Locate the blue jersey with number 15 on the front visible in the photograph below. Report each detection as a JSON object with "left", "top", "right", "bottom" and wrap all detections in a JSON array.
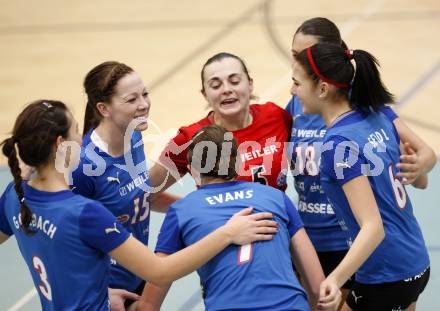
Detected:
[{"left": 72, "top": 131, "right": 150, "bottom": 291}]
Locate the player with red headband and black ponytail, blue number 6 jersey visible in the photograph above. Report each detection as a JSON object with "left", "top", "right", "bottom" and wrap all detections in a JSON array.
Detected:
[{"left": 292, "top": 43, "right": 429, "bottom": 310}]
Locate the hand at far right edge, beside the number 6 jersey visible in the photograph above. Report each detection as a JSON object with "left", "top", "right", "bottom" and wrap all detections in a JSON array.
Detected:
[{"left": 396, "top": 143, "right": 422, "bottom": 185}]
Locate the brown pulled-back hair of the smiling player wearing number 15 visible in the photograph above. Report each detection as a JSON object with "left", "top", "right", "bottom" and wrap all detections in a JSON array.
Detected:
[{"left": 83, "top": 61, "right": 133, "bottom": 135}]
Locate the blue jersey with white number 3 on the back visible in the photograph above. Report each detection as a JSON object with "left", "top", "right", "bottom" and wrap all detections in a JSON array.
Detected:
[{"left": 0, "top": 183, "right": 129, "bottom": 310}]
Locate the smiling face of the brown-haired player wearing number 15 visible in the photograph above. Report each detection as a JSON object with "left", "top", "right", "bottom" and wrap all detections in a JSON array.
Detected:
[{"left": 106, "top": 72, "right": 151, "bottom": 131}]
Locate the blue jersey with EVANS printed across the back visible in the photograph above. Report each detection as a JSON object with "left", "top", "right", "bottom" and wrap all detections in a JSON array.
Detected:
[{"left": 156, "top": 181, "right": 309, "bottom": 310}]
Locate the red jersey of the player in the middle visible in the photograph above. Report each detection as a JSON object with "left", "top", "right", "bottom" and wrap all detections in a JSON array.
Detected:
[{"left": 161, "top": 102, "right": 292, "bottom": 191}]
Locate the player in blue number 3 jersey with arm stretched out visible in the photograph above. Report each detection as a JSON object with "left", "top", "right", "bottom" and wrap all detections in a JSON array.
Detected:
[{"left": 0, "top": 100, "right": 276, "bottom": 310}]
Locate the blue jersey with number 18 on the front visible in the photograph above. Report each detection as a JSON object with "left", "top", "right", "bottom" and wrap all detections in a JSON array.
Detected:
[{"left": 286, "top": 96, "right": 349, "bottom": 252}]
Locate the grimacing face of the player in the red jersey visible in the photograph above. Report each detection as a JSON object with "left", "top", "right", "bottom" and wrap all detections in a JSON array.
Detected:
[{"left": 202, "top": 57, "right": 253, "bottom": 117}]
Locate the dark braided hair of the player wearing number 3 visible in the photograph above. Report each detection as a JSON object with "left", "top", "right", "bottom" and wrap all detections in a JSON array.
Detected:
[{"left": 0, "top": 100, "right": 72, "bottom": 235}]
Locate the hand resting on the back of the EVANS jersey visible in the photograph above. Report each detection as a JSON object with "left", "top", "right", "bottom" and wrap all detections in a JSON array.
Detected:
[{"left": 224, "top": 207, "right": 278, "bottom": 245}]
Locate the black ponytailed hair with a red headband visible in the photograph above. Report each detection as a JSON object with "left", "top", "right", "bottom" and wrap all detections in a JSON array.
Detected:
[{"left": 295, "top": 43, "right": 394, "bottom": 113}]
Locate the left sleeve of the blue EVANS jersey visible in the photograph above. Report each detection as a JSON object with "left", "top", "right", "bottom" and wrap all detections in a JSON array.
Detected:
[{"left": 154, "top": 206, "right": 185, "bottom": 254}]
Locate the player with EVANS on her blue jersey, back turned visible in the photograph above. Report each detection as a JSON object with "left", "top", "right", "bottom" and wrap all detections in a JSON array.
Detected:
[{"left": 142, "top": 125, "right": 340, "bottom": 310}]
